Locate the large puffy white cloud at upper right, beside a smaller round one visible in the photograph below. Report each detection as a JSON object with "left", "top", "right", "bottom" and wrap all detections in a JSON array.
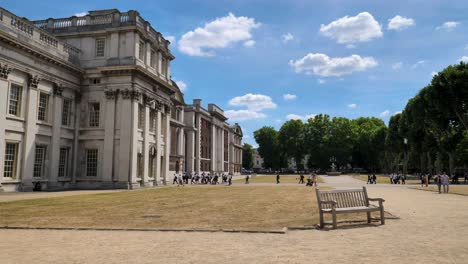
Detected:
[{"left": 320, "top": 12, "right": 383, "bottom": 44}]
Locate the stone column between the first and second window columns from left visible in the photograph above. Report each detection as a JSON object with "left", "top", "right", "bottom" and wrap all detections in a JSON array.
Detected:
[{"left": 21, "top": 75, "right": 40, "bottom": 191}]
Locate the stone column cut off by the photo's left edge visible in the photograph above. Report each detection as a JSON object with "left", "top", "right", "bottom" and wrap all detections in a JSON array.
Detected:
[{"left": 0, "top": 64, "right": 12, "bottom": 192}]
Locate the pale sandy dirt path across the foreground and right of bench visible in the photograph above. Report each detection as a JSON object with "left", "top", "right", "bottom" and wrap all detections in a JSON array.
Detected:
[{"left": 0, "top": 176, "right": 468, "bottom": 264}]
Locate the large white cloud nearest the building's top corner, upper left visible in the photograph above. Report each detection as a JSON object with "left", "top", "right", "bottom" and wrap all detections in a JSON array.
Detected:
[{"left": 179, "top": 13, "right": 260, "bottom": 56}]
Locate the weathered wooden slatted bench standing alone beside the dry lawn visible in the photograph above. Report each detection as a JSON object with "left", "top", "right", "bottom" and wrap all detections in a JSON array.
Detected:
[{"left": 315, "top": 187, "right": 385, "bottom": 228}]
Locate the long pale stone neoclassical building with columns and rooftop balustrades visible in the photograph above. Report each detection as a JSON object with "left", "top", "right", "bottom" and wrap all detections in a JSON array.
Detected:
[{"left": 0, "top": 8, "right": 242, "bottom": 191}]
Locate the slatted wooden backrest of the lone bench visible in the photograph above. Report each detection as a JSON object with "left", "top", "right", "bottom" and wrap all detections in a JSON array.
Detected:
[{"left": 316, "top": 187, "right": 369, "bottom": 209}]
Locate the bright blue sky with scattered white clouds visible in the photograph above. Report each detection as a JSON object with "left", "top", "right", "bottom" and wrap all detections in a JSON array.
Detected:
[{"left": 0, "top": 0, "right": 468, "bottom": 146}]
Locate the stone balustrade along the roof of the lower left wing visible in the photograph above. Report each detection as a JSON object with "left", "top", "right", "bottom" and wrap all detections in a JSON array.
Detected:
[{"left": 0, "top": 8, "right": 80, "bottom": 65}]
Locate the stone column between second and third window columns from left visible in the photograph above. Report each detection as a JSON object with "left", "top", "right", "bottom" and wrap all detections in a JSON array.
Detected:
[{"left": 47, "top": 85, "right": 63, "bottom": 189}]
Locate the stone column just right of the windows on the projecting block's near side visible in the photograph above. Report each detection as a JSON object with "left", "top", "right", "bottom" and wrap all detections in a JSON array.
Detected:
[{"left": 102, "top": 90, "right": 118, "bottom": 187}]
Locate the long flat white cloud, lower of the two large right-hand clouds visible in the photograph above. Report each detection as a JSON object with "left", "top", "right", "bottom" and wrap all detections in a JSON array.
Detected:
[{"left": 289, "top": 53, "right": 378, "bottom": 77}]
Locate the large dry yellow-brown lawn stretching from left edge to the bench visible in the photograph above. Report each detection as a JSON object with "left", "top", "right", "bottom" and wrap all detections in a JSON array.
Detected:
[{"left": 0, "top": 186, "right": 340, "bottom": 230}]
